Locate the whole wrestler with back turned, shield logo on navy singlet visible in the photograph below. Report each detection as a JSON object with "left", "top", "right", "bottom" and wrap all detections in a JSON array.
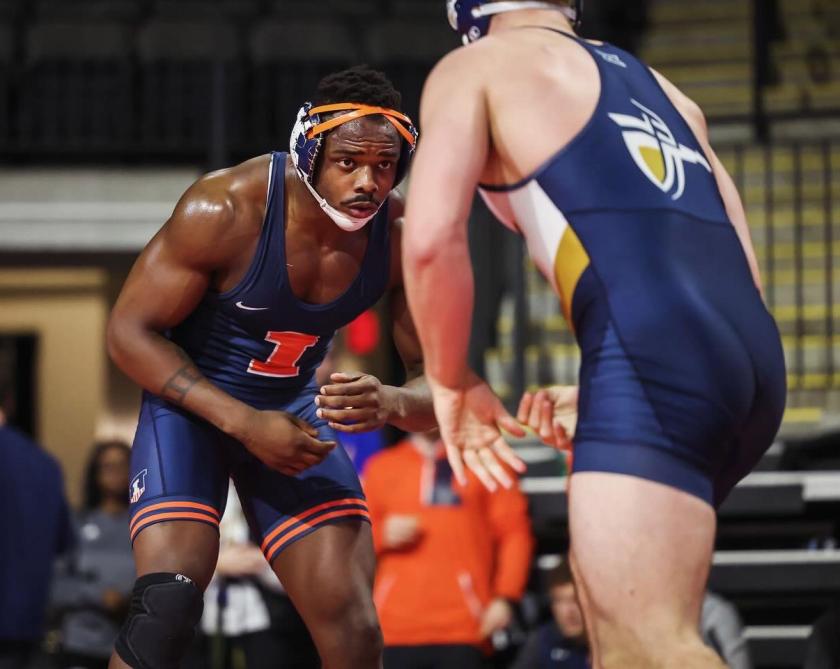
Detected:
[{"left": 403, "top": 0, "right": 785, "bottom": 669}]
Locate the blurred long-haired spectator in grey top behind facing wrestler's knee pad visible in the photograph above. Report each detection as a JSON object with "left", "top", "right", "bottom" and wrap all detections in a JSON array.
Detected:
[{"left": 52, "top": 441, "right": 134, "bottom": 669}]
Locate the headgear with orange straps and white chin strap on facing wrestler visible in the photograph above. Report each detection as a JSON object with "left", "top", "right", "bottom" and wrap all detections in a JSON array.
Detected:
[{"left": 289, "top": 102, "right": 418, "bottom": 232}]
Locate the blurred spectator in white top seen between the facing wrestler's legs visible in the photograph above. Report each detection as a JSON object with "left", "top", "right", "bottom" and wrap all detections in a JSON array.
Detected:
[{"left": 184, "top": 485, "right": 320, "bottom": 669}]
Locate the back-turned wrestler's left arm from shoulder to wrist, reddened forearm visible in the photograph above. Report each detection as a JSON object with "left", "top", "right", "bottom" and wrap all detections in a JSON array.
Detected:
[{"left": 403, "top": 51, "right": 489, "bottom": 388}]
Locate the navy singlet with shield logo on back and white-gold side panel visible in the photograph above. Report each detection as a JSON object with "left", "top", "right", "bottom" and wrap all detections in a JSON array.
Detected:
[{"left": 482, "top": 27, "right": 786, "bottom": 504}]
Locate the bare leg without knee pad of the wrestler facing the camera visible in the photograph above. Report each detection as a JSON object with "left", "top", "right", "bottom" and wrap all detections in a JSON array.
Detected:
[{"left": 272, "top": 520, "right": 382, "bottom": 669}]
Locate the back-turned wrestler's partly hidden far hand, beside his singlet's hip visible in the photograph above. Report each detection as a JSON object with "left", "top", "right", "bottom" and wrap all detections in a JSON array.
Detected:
[{"left": 516, "top": 386, "right": 578, "bottom": 451}]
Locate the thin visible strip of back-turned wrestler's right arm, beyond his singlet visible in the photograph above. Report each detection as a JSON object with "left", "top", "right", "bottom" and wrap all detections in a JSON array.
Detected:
[{"left": 653, "top": 70, "right": 761, "bottom": 291}]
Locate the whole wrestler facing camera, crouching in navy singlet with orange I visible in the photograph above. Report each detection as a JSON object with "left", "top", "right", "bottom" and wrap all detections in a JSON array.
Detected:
[{"left": 108, "top": 68, "right": 433, "bottom": 669}]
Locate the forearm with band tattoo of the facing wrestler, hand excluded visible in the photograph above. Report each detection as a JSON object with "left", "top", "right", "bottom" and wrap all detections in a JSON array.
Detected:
[{"left": 108, "top": 326, "right": 253, "bottom": 437}]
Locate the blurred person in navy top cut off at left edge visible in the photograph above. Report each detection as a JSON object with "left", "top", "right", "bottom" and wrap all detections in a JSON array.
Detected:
[{"left": 0, "top": 366, "right": 73, "bottom": 669}]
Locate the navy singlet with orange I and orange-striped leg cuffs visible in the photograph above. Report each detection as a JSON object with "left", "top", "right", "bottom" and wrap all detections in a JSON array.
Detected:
[{"left": 131, "top": 152, "right": 390, "bottom": 560}]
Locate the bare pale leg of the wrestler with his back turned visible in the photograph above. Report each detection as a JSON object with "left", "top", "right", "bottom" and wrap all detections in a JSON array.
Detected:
[{"left": 569, "top": 471, "right": 724, "bottom": 669}]
